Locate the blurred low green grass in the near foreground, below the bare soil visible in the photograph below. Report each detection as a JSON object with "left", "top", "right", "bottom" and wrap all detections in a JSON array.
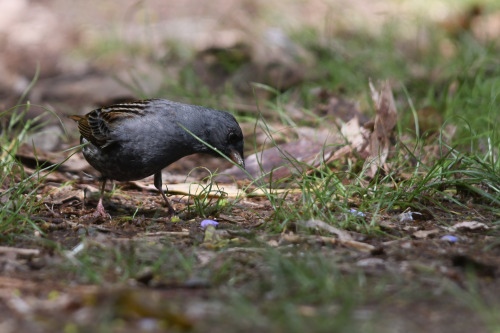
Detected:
[{"left": 52, "top": 239, "right": 498, "bottom": 332}]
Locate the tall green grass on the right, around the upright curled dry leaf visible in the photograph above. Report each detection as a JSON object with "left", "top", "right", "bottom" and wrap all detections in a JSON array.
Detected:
[{"left": 252, "top": 16, "right": 500, "bottom": 231}]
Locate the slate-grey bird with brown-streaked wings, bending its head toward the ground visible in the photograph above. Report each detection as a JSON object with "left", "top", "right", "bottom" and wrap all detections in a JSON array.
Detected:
[{"left": 70, "top": 99, "right": 245, "bottom": 218}]
